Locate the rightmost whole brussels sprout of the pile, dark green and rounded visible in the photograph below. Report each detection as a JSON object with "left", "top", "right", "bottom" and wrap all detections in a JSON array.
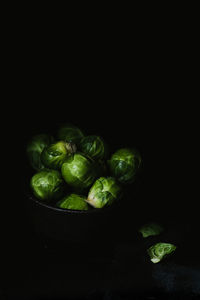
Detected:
[{"left": 108, "top": 148, "right": 141, "bottom": 184}]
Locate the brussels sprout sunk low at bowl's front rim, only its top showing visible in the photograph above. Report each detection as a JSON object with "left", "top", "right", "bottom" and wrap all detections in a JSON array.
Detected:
[{"left": 56, "top": 194, "right": 89, "bottom": 210}]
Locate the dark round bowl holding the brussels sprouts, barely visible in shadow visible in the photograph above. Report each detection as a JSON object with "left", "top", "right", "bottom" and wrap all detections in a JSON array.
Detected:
[{"left": 26, "top": 188, "right": 122, "bottom": 242}]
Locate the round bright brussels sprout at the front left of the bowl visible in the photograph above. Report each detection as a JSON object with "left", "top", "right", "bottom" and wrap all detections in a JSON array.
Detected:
[{"left": 30, "top": 170, "right": 64, "bottom": 202}]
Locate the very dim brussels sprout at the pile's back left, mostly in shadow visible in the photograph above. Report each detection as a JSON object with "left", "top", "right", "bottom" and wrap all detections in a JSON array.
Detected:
[{"left": 26, "top": 134, "right": 53, "bottom": 171}]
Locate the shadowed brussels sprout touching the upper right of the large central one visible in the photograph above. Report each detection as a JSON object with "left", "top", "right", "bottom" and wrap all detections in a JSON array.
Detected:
[{"left": 79, "top": 135, "right": 108, "bottom": 160}]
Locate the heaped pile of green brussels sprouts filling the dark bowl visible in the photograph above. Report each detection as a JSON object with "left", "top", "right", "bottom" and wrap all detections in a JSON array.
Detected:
[{"left": 26, "top": 124, "right": 141, "bottom": 210}]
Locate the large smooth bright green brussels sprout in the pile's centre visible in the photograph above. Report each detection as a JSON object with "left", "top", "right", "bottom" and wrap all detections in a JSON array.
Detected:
[{"left": 61, "top": 152, "right": 97, "bottom": 190}]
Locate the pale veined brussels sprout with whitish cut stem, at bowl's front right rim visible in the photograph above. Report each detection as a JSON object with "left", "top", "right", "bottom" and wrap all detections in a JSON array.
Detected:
[{"left": 86, "top": 177, "right": 121, "bottom": 208}]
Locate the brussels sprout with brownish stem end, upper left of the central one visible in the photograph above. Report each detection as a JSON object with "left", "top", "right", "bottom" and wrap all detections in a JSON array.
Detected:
[{"left": 41, "top": 141, "right": 76, "bottom": 170}]
